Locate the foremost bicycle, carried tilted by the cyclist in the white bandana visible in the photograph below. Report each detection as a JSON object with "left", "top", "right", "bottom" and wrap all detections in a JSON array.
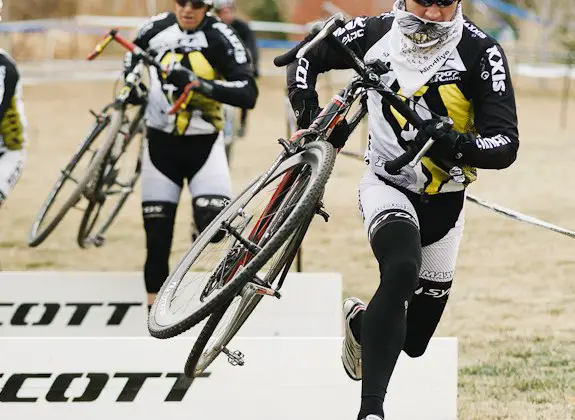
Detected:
[{"left": 148, "top": 14, "right": 448, "bottom": 377}]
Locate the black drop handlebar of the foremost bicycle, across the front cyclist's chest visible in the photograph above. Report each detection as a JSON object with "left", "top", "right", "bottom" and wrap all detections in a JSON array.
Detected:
[{"left": 274, "top": 13, "right": 435, "bottom": 175}]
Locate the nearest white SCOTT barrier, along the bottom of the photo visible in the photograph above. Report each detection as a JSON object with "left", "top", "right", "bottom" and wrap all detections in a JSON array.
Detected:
[{"left": 0, "top": 338, "right": 457, "bottom": 420}]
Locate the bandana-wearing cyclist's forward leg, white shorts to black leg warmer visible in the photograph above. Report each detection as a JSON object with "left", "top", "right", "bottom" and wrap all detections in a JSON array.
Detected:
[{"left": 351, "top": 171, "right": 421, "bottom": 419}]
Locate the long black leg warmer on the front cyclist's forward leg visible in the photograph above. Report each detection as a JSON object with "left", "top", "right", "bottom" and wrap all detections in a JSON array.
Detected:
[{"left": 359, "top": 212, "right": 421, "bottom": 418}]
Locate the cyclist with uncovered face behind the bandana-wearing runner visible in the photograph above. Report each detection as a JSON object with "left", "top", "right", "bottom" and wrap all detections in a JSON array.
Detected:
[{"left": 125, "top": 0, "right": 258, "bottom": 304}]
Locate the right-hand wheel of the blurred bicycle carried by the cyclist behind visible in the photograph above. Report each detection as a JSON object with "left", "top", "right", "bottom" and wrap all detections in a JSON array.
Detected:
[{"left": 77, "top": 109, "right": 146, "bottom": 248}]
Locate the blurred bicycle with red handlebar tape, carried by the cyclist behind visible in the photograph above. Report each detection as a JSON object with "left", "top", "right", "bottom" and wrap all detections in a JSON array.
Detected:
[{"left": 28, "top": 34, "right": 147, "bottom": 248}]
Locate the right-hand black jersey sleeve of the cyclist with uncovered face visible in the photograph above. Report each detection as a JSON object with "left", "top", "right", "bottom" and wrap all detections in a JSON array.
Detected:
[{"left": 201, "top": 22, "right": 258, "bottom": 109}]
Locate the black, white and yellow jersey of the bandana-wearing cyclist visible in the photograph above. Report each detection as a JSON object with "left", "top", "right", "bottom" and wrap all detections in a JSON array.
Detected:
[{"left": 288, "top": 13, "right": 519, "bottom": 195}]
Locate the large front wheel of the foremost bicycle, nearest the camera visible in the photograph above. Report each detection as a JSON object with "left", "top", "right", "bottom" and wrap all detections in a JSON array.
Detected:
[{"left": 148, "top": 141, "right": 335, "bottom": 338}]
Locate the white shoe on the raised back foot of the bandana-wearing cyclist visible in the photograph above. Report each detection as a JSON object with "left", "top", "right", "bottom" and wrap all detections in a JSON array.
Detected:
[{"left": 341, "top": 297, "right": 364, "bottom": 380}]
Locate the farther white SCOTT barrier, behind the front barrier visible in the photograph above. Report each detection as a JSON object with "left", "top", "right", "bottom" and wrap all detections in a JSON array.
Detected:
[{"left": 0, "top": 271, "right": 342, "bottom": 337}]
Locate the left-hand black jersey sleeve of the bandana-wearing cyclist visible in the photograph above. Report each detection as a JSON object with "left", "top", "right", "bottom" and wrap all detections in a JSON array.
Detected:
[{"left": 287, "top": 16, "right": 383, "bottom": 107}]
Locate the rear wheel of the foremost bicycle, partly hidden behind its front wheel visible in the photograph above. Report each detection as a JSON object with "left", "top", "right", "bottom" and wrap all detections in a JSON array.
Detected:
[{"left": 184, "top": 213, "right": 313, "bottom": 378}]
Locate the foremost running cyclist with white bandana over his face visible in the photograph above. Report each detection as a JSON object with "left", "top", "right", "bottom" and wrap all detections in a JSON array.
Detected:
[{"left": 287, "top": 0, "right": 519, "bottom": 420}]
